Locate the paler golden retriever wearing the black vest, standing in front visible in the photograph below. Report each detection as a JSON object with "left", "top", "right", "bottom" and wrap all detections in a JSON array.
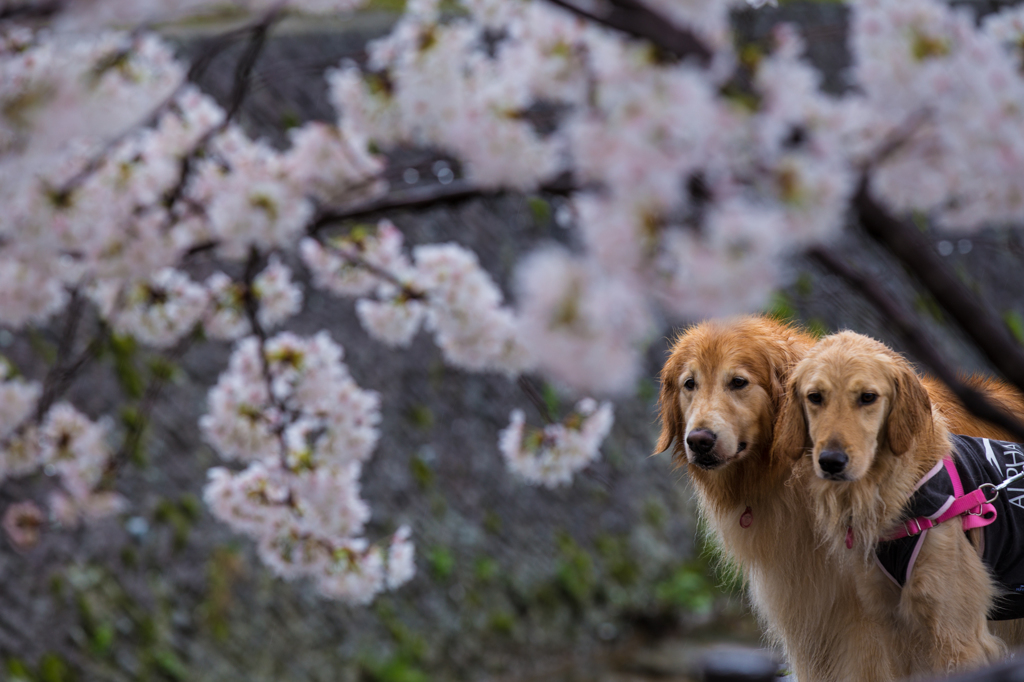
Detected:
[{"left": 775, "top": 332, "right": 1007, "bottom": 675}]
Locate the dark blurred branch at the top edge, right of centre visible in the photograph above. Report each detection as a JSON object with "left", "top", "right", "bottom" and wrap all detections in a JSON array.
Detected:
[{"left": 548, "top": 0, "right": 712, "bottom": 67}]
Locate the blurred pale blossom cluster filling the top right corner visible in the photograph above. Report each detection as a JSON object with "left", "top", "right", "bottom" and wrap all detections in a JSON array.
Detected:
[{"left": 853, "top": 0, "right": 1024, "bottom": 228}]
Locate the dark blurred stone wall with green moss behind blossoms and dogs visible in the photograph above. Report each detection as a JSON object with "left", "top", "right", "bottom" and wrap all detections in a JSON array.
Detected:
[{"left": 6, "top": 2, "right": 1024, "bottom": 682}]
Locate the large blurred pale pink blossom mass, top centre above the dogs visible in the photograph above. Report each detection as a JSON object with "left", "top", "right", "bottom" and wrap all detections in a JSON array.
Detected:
[{"left": 332, "top": 0, "right": 866, "bottom": 392}]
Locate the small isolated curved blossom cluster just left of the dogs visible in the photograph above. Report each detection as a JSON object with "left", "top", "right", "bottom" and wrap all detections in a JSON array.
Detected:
[{"left": 498, "top": 398, "right": 612, "bottom": 487}]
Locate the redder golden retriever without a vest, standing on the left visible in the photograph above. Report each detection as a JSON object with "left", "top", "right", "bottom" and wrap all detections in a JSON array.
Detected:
[{"left": 655, "top": 316, "right": 1024, "bottom": 682}]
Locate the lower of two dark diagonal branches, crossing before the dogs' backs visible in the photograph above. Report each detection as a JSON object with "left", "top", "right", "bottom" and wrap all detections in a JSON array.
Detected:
[{"left": 807, "top": 242, "right": 1024, "bottom": 442}]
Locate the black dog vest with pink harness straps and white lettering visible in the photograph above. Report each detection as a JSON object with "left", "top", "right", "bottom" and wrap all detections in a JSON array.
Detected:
[{"left": 872, "top": 435, "right": 1024, "bottom": 621}]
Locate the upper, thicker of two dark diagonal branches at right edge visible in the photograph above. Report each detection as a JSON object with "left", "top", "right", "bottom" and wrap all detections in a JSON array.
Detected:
[{"left": 854, "top": 176, "right": 1024, "bottom": 395}]
